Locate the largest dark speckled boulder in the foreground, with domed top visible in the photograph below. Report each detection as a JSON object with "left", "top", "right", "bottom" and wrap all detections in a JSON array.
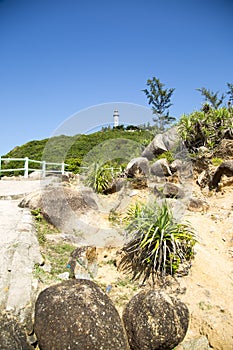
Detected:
[{"left": 34, "top": 279, "right": 129, "bottom": 350}]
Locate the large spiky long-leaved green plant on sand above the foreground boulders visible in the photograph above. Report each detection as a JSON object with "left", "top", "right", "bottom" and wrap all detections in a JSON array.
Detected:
[{"left": 120, "top": 201, "right": 196, "bottom": 283}]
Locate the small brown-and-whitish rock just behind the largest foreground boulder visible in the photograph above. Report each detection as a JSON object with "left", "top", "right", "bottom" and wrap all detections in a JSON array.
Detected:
[{"left": 68, "top": 246, "right": 98, "bottom": 279}]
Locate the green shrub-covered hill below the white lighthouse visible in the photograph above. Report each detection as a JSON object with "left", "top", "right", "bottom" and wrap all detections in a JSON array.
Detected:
[{"left": 2, "top": 129, "right": 153, "bottom": 172}]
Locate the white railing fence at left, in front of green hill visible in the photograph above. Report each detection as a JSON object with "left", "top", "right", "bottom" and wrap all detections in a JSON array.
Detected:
[{"left": 0, "top": 156, "right": 68, "bottom": 179}]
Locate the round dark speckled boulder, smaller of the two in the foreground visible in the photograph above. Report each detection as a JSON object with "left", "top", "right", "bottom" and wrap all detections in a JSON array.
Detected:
[{"left": 123, "top": 290, "right": 189, "bottom": 350}]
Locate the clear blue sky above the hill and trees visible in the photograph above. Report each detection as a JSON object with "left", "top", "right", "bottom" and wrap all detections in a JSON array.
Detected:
[{"left": 0, "top": 0, "right": 233, "bottom": 155}]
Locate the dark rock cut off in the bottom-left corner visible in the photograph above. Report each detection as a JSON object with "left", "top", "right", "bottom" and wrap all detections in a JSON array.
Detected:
[{"left": 0, "top": 313, "right": 34, "bottom": 350}]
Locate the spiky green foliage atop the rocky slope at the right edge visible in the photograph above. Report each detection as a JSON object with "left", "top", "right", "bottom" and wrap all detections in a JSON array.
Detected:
[{"left": 178, "top": 107, "right": 233, "bottom": 151}]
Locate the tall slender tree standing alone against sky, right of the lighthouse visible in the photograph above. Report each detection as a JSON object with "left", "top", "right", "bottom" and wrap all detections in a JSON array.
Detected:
[{"left": 142, "top": 77, "right": 175, "bottom": 130}]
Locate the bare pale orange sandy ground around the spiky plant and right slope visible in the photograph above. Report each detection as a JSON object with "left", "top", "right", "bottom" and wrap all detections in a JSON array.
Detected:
[{"left": 94, "top": 185, "right": 233, "bottom": 350}]
